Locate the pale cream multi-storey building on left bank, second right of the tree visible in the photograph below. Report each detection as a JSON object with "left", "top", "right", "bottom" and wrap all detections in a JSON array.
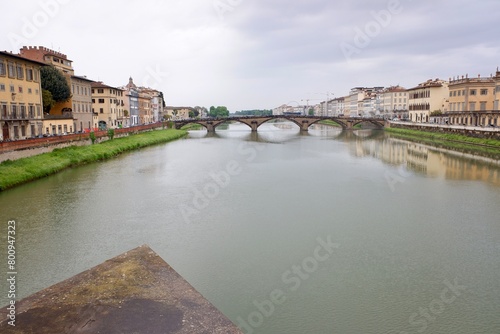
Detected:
[{"left": 91, "top": 81, "right": 125, "bottom": 129}]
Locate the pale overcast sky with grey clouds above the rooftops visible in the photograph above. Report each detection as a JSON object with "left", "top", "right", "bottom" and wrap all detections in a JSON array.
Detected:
[{"left": 0, "top": 0, "right": 500, "bottom": 112}]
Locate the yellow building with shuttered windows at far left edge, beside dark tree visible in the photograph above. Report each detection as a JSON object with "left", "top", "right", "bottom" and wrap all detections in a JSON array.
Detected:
[{"left": 0, "top": 51, "right": 44, "bottom": 140}]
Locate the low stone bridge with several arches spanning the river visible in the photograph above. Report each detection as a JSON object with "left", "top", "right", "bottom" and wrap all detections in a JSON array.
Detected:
[{"left": 173, "top": 115, "right": 385, "bottom": 132}]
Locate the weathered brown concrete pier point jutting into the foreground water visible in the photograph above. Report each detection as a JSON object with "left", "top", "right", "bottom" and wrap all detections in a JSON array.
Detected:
[{"left": 0, "top": 246, "right": 242, "bottom": 334}]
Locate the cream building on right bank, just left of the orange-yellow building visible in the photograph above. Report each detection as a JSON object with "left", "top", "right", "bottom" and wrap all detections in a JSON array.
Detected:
[{"left": 408, "top": 79, "right": 449, "bottom": 123}]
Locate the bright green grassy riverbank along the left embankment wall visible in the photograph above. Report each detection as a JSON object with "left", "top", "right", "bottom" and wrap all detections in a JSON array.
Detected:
[{"left": 0, "top": 129, "right": 187, "bottom": 191}]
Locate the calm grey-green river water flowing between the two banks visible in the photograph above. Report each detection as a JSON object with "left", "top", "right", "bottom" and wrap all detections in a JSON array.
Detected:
[{"left": 0, "top": 123, "right": 500, "bottom": 334}]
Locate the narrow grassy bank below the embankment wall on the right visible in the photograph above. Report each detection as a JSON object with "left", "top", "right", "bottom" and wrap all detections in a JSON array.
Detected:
[{"left": 384, "top": 128, "right": 500, "bottom": 159}]
